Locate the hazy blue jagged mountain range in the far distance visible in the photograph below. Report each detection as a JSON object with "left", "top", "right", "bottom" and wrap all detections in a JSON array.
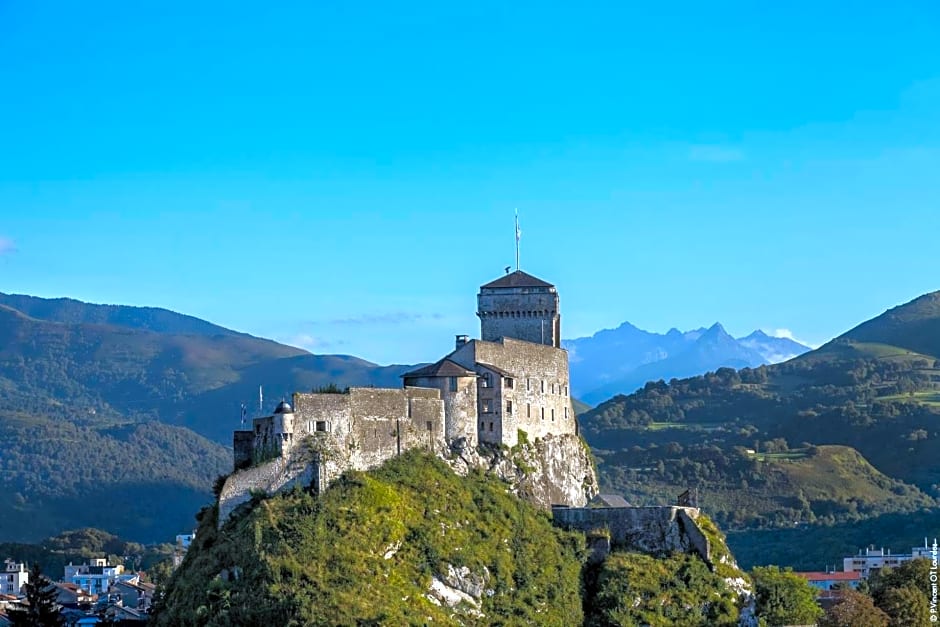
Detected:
[{"left": 562, "top": 322, "right": 810, "bottom": 404}]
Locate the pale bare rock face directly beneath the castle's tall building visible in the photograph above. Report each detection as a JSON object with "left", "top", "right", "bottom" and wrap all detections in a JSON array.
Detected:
[{"left": 444, "top": 432, "right": 597, "bottom": 509}]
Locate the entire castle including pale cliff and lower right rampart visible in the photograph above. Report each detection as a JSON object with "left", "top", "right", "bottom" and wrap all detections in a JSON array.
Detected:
[{"left": 218, "top": 270, "right": 713, "bottom": 588}]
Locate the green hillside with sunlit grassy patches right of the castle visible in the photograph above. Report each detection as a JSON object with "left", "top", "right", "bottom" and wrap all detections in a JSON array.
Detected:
[{"left": 580, "top": 293, "right": 940, "bottom": 568}]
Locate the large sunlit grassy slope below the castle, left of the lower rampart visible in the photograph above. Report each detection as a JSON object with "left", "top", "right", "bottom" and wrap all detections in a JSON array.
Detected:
[{"left": 154, "top": 452, "right": 583, "bottom": 626}]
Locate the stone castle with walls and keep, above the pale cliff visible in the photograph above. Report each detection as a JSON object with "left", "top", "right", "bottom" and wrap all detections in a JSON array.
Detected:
[{"left": 220, "top": 270, "right": 593, "bottom": 511}]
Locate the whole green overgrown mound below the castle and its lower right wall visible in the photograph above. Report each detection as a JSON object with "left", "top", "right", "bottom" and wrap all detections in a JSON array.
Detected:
[{"left": 153, "top": 451, "right": 740, "bottom": 627}]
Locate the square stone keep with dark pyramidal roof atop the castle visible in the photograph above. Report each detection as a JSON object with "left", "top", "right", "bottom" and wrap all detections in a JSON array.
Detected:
[{"left": 477, "top": 270, "right": 561, "bottom": 348}]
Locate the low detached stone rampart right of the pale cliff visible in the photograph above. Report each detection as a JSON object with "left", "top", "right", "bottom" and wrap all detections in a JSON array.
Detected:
[{"left": 552, "top": 506, "right": 712, "bottom": 566}]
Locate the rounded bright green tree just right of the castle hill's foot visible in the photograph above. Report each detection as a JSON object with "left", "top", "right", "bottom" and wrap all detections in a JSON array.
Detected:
[{"left": 751, "top": 566, "right": 823, "bottom": 625}]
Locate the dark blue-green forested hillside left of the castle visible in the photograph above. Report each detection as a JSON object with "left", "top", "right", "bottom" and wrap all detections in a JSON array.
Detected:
[{"left": 0, "top": 294, "right": 408, "bottom": 542}]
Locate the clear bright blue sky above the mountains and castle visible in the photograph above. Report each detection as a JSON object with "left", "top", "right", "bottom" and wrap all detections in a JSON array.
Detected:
[{"left": 0, "top": 1, "right": 940, "bottom": 363}]
